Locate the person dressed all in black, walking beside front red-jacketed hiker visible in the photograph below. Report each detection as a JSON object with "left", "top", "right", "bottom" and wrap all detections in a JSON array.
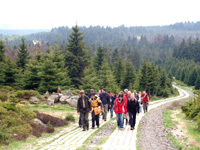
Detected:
[{"left": 127, "top": 94, "right": 139, "bottom": 130}]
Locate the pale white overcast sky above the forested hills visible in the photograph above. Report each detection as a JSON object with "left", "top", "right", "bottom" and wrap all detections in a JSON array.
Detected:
[{"left": 0, "top": 0, "right": 200, "bottom": 29}]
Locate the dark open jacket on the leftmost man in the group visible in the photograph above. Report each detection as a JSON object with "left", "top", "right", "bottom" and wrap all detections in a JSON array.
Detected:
[{"left": 77, "top": 96, "right": 91, "bottom": 113}]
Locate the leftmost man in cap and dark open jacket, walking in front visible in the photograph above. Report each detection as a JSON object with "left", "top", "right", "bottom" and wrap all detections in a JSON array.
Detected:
[{"left": 77, "top": 90, "right": 91, "bottom": 131}]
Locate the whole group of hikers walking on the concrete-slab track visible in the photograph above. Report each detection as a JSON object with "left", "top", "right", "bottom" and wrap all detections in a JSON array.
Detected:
[{"left": 77, "top": 88, "right": 149, "bottom": 131}]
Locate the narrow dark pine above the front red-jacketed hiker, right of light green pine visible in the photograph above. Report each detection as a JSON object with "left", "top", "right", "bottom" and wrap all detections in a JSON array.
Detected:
[{"left": 114, "top": 56, "right": 124, "bottom": 86}]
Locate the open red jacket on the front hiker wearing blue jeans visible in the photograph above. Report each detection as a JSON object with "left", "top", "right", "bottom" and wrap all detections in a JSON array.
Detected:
[{"left": 114, "top": 98, "right": 127, "bottom": 114}]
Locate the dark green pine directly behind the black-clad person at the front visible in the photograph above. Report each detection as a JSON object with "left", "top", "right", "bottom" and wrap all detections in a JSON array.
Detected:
[{"left": 121, "top": 61, "right": 136, "bottom": 89}]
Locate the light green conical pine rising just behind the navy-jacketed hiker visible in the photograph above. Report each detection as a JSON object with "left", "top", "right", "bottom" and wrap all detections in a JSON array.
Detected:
[{"left": 99, "top": 62, "right": 119, "bottom": 93}]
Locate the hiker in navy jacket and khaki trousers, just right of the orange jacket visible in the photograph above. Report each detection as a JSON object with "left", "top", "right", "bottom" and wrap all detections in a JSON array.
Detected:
[{"left": 99, "top": 88, "right": 110, "bottom": 121}]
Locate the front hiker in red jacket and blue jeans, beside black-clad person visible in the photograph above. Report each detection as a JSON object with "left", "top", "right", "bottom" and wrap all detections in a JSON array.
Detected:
[{"left": 114, "top": 91, "right": 127, "bottom": 130}]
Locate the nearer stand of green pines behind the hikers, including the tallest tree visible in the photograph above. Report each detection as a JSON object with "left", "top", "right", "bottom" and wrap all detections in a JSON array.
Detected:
[{"left": 0, "top": 26, "right": 174, "bottom": 97}]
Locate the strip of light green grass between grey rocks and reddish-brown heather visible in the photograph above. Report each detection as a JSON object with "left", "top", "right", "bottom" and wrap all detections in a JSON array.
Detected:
[{"left": 24, "top": 104, "right": 76, "bottom": 112}]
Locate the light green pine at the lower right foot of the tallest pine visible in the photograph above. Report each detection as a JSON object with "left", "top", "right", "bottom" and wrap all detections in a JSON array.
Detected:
[{"left": 81, "top": 65, "right": 99, "bottom": 93}]
